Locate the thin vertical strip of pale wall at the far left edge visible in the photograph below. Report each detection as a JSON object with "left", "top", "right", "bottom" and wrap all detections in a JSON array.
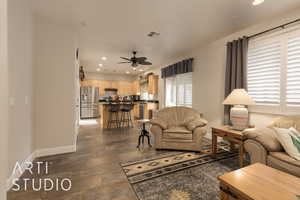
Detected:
[{"left": 0, "top": 0, "right": 8, "bottom": 197}]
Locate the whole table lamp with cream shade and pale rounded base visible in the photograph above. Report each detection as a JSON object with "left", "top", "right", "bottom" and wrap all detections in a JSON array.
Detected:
[{"left": 223, "top": 89, "right": 255, "bottom": 131}]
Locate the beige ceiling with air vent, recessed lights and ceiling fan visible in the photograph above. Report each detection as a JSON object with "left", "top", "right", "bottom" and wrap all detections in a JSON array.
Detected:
[{"left": 32, "top": 0, "right": 300, "bottom": 74}]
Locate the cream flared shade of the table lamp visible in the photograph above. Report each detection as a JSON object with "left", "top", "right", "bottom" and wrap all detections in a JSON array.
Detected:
[{"left": 223, "top": 89, "right": 255, "bottom": 105}]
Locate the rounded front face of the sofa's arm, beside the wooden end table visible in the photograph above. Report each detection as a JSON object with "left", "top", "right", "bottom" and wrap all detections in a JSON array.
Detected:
[{"left": 244, "top": 139, "right": 268, "bottom": 164}]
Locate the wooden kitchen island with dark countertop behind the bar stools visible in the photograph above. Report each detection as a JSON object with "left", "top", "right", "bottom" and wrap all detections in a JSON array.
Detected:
[{"left": 99, "top": 100, "right": 159, "bottom": 128}]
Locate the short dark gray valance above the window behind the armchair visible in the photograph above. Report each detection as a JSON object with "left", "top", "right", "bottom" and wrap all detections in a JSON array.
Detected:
[{"left": 161, "top": 58, "right": 193, "bottom": 78}]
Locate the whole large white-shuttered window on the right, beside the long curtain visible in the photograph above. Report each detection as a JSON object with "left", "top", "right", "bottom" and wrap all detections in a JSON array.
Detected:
[{"left": 247, "top": 27, "right": 300, "bottom": 114}]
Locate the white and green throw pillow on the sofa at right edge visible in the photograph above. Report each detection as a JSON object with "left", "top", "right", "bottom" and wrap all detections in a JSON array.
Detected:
[{"left": 274, "top": 128, "right": 300, "bottom": 160}]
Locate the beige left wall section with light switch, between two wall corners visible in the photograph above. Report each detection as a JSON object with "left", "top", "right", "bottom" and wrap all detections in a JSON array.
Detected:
[{"left": 8, "top": 0, "right": 34, "bottom": 180}]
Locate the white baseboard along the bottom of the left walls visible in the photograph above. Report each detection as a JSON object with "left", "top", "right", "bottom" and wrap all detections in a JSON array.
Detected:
[{"left": 6, "top": 144, "right": 76, "bottom": 191}]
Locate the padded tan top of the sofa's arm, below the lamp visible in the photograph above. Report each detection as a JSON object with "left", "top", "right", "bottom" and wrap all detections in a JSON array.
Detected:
[{"left": 243, "top": 128, "right": 283, "bottom": 152}]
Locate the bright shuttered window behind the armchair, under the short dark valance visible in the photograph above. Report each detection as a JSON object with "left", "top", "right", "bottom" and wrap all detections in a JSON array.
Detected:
[{"left": 165, "top": 73, "right": 193, "bottom": 107}]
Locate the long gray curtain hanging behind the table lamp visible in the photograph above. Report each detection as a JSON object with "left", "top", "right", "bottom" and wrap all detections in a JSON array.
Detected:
[{"left": 224, "top": 37, "right": 248, "bottom": 125}]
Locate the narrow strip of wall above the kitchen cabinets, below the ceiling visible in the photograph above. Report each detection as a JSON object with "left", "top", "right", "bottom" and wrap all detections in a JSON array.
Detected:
[{"left": 85, "top": 72, "right": 137, "bottom": 81}]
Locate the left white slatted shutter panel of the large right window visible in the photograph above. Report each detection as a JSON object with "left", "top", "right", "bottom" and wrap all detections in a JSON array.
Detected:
[{"left": 247, "top": 40, "right": 281, "bottom": 106}]
